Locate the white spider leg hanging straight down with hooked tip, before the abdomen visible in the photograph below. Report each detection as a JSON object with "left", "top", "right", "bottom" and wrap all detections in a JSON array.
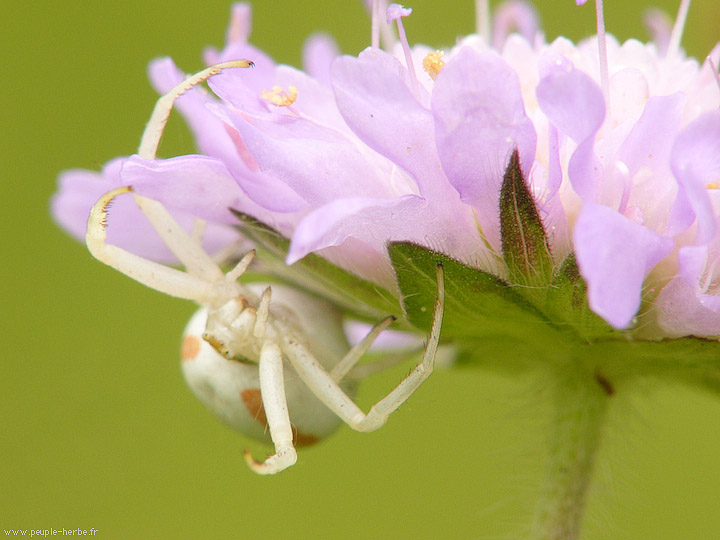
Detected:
[{"left": 244, "top": 340, "right": 297, "bottom": 474}]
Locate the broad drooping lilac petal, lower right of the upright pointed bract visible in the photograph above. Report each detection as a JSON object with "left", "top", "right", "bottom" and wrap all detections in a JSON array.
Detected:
[{"left": 573, "top": 203, "right": 673, "bottom": 328}]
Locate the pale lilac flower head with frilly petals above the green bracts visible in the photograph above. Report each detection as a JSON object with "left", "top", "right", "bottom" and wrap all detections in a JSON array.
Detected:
[{"left": 53, "top": 1, "right": 720, "bottom": 339}]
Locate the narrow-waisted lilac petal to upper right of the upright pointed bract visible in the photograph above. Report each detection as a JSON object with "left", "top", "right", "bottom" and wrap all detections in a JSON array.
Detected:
[{"left": 536, "top": 68, "right": 605, "bottom": 200}]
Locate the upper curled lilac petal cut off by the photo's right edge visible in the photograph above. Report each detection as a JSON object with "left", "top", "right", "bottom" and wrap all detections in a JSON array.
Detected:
[{"left": 670, "top": 111, "right": 720, "bottom": 244}]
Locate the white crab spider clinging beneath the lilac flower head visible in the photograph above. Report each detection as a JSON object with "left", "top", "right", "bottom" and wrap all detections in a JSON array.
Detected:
[{"left": 86, "top": 60, "right": 444, "bottom": 474}]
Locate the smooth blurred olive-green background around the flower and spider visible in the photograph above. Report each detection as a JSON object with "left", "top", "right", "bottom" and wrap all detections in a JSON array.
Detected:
[{"left": 0, "top": 0, "right": 720, "bottom": 540}]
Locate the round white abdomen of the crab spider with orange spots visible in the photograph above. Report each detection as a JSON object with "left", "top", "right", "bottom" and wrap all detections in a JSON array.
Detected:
[{"left": 181, "top": 284, "right": 380, "bottom": 447}]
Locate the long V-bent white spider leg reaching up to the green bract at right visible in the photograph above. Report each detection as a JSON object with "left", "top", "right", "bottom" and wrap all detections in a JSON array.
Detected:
[{"left": 282, "top": 265, "right": 445, "bottom": 431}]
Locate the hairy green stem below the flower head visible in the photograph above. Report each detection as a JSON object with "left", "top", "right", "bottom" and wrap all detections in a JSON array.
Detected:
[{"left": 530, "top": 365, "right": 613, "bottom": 540}]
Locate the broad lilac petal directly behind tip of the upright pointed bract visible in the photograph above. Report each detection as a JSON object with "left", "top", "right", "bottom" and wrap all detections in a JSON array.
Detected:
[{"left": 432, "top": 47, "right": 536, "bottom": 249}]
